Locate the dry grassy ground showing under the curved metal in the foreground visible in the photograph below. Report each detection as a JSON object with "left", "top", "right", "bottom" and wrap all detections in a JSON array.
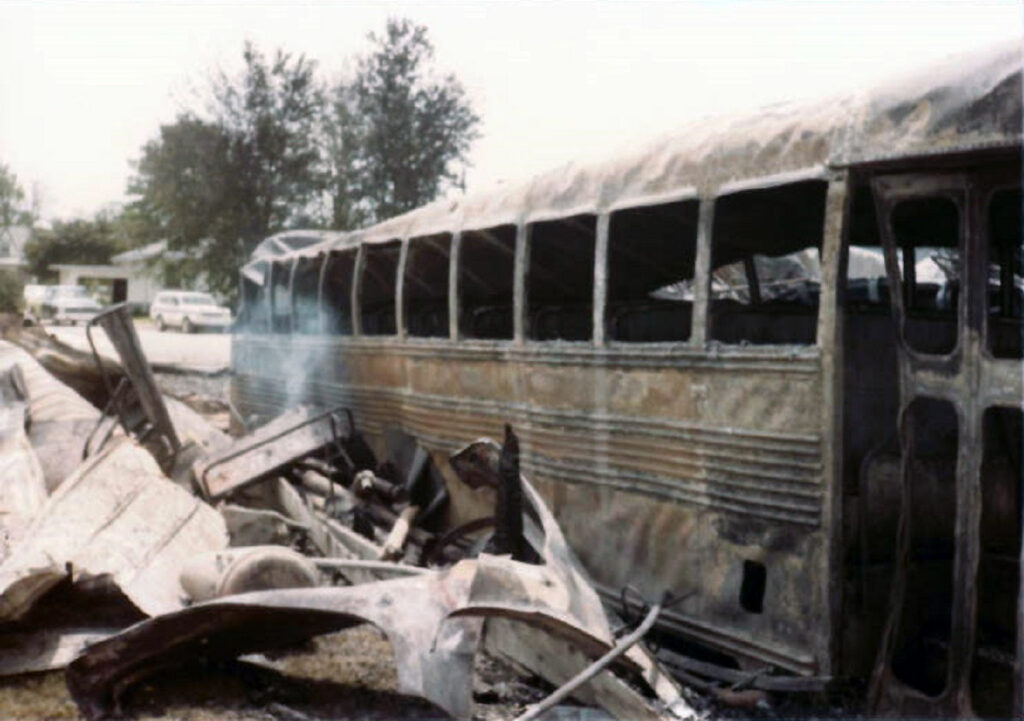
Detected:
[{"left": 0, "top": 626, "right": 544, "bottom": 721}]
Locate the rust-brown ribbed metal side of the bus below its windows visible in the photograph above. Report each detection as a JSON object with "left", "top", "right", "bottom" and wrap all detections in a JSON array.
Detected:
[{"left": 233, "top": 336, "right": 828, "bottom": 674}]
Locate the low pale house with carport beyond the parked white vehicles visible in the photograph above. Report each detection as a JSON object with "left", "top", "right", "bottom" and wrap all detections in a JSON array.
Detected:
[{"left": 50, "top": 241, "right": 181, "bottom": 308}]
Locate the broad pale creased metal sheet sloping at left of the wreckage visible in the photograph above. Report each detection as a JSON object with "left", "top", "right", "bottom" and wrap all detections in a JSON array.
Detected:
[{"left": 0, "top": 437, "right": 227, "bottom": 621}]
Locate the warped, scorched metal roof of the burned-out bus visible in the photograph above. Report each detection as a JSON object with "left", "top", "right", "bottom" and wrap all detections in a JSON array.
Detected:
[{"left": 244, "top": 40, "right": 1022, "bottom": 283}]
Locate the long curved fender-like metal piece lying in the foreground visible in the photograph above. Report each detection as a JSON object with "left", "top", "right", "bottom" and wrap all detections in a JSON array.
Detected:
[{"left": 68, "top": 561, "right": 482, "bottom": 719}]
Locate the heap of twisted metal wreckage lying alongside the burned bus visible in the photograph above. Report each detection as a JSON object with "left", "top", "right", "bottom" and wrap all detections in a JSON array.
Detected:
[{"left": 0, "top": 307, "right": 695, "bottom": 720}]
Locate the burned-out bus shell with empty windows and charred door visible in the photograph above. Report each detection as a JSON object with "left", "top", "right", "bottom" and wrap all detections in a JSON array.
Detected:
[{"left": 232, "top": 44, "right": 1024, "bottom": 716}]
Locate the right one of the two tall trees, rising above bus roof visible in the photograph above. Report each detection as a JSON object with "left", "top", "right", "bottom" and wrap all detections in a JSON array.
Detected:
[{"left": 326, "top": 19, "right": 480, "bottom": 228}]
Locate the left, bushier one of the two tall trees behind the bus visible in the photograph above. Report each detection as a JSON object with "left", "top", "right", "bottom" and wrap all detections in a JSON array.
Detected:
[{"left": 128, "top": 43, "right": 324, "bottom": 296}]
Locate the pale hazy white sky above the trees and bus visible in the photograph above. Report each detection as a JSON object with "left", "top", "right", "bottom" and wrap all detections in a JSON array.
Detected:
[{"left": 0, "top": 0, "right": 1024, "bottom": 217}]
